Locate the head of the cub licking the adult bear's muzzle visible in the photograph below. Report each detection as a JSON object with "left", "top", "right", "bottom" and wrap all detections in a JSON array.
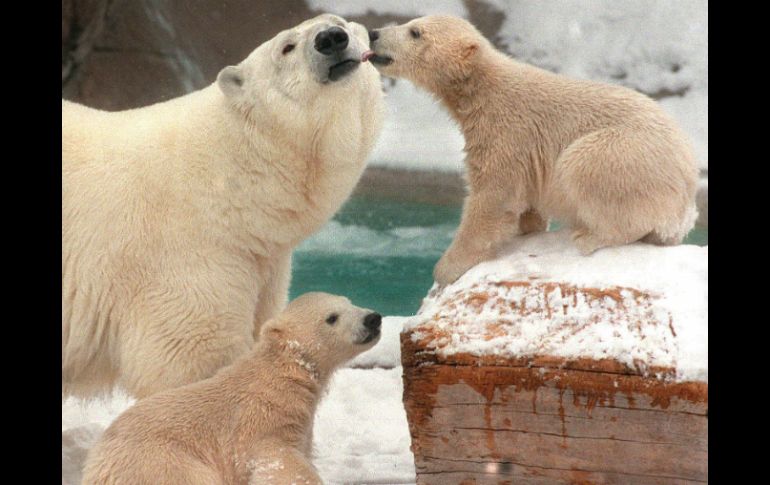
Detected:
[{"left": 369, "top": 15, "right": 484, "bottom": 91}]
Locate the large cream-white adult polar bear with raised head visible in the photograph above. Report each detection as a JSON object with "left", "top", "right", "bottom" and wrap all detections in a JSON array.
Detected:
[{"left": 62, "top": 15, "right": 383, "bottom": 397}]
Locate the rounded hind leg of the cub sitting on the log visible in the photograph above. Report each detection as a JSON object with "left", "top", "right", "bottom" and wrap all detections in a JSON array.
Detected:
[{"left": 550, "top": 127, "right": 690, "bottom": 254}]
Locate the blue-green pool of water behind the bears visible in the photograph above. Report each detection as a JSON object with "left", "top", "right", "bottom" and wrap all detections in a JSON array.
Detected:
[{"left": 289, "top": 197, "right": 708, "bottom": 315}]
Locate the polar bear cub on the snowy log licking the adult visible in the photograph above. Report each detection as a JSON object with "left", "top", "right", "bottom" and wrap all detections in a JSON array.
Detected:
[{"left": 370, "top": 16, "right": 698, "bottom": 285}]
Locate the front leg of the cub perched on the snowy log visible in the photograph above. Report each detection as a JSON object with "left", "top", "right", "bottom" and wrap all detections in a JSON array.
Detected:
[{"left": 433, "top": 183, "right": 527, "bottom": 286}]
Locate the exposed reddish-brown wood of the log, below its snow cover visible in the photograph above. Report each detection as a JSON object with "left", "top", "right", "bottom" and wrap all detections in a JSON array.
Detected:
[{"left": 401, "top": 283, "right": 708, "bottom": 485}]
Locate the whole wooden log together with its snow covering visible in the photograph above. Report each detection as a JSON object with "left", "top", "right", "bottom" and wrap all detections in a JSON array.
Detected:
[{"left": 401, "top": 231, "right": 708, "bottom": 485}]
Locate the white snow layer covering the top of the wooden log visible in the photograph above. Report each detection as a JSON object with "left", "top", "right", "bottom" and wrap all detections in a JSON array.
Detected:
[{"left": 404, "top": 230, "right": 708, "bottom": 382}]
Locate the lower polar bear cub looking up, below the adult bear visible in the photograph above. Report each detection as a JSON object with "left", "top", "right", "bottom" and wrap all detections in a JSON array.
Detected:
[{"left": 83, "top": 293, "right": 381, "bottom": 485}]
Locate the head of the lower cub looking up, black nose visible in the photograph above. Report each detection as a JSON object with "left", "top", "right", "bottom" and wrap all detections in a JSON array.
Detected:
[{"left": 268, "top": 293, "right": 382, "bottom": 368}]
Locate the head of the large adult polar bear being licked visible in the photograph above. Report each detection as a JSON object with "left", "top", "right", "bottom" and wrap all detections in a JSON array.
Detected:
[{"left": 217, "top": 14, "right": 374, "bottom": 100}]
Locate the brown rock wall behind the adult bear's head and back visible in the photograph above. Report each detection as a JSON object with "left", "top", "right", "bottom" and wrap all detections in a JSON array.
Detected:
[{"left": 62, "top": 0, "right": 510, "bottom": 110}]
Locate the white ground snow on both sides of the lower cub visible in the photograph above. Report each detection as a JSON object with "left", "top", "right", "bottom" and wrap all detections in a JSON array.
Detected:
[{"left": 62, "top": 317, "right": 415, "bottom": 485}]
